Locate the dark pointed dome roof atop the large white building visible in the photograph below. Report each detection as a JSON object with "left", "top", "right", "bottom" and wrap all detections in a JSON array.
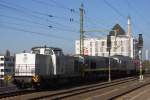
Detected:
[{"left": 109, "top": 24, "right": 126, "bottom": 36}]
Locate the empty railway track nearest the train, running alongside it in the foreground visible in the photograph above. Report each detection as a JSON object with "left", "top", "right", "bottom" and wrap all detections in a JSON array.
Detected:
[{"left": 30, "top": 77, "right": 137, "bottom": 100}]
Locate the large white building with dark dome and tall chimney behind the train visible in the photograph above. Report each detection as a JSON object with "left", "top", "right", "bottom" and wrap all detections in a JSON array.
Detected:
[{"left": 75, "top": 17, "right": 135, "bottom": 58}]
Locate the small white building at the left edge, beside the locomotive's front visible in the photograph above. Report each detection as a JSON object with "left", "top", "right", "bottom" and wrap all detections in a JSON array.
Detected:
[{"left": 0, "top": 51, "right": 14, "bottom": 80}]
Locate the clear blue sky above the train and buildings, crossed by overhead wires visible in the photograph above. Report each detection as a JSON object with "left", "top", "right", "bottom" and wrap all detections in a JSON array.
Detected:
[{"left": 0, "top": 0, "right": 150, "bottom": 53}]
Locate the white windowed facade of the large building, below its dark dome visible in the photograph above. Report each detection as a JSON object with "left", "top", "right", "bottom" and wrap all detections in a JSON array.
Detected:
[{"left": 75, "top": 36, "right": 134, "bottom": 58}]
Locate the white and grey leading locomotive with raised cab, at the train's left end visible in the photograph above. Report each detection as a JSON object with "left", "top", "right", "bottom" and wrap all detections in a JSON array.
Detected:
[{"left": 14, "top": 47, "right": 79, "bottom": 88}]
